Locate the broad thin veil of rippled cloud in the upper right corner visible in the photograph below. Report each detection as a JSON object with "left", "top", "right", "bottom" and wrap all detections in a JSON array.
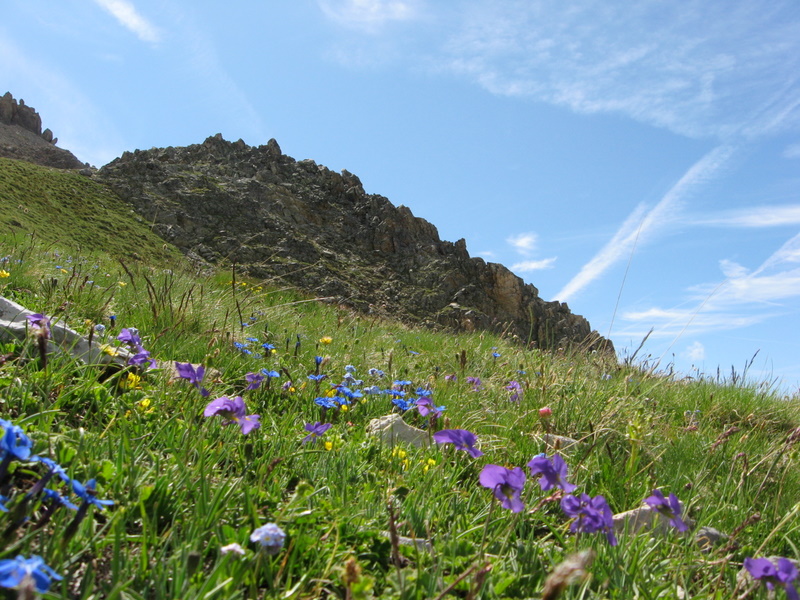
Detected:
[{"left": 447, "top": 0, "right": 800, "bottom": 139}]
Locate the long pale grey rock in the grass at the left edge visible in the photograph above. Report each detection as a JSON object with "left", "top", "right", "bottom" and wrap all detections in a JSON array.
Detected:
[{"left": 0, "top": 296, "right": 132, "bottom": 366}]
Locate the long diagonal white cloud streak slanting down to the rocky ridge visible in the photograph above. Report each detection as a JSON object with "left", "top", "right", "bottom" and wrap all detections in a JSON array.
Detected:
[{"left": 556, "top": 146, "right": 735, "bottom": 302}]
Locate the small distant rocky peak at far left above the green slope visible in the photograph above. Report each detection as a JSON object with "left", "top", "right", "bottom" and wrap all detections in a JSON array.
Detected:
[{"left": 0, "top": 92, "right": 86, "bottom": 169}]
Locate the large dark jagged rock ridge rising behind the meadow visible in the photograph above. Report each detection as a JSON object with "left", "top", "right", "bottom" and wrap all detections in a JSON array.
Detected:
[{"left": 96, "top": 134, "right": 611, "bottom": 349}]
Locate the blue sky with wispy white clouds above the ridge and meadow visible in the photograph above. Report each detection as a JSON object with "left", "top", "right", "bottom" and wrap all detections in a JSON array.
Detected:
[{"left": 0, "top": 0, "right": 800, "bottom": 394}]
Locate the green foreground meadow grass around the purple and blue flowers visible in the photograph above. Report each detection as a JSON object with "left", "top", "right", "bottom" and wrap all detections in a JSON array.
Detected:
[{"left": 0, "top": 176, "right": 800, "bottom": 599}]
